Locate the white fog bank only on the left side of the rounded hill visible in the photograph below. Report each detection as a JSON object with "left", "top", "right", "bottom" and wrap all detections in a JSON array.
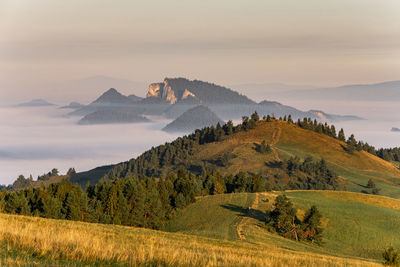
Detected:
[{"left": 0, "top": 107, "right": 177, "bottom": 184}]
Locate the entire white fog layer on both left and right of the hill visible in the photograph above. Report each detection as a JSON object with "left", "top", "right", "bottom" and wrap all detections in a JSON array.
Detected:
[{"left": 0, "top": 98, "right": 400, "bottom": 184}]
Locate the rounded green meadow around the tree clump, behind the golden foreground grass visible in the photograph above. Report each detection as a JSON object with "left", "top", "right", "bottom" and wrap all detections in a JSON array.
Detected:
[{"left": 168, "top": 191, "right": 400, "bottom": 264}]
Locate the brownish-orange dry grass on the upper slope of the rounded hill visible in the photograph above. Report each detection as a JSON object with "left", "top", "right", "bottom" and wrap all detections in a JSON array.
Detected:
[{"left": 193, "top": 121, "right": 400, "bottom": 180}]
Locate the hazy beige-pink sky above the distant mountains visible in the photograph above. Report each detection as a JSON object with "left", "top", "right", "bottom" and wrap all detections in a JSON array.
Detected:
[{"left": 0, "top": 0, "right": 400, "bottom": 102}]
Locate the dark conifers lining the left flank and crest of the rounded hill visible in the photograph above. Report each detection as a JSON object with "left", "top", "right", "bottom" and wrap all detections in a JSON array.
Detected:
[{"left": 104, "top": 112, "right": 400, "bottom": 184}]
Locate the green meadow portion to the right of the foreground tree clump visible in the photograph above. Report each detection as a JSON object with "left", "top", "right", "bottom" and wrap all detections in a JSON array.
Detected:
[{"left": 288, "top": 191, "right": 400, "bottom": 258}]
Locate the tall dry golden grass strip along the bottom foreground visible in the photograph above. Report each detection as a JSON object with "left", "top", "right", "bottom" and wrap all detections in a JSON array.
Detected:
[{"left": 0, "top": 214, "right": 378, "bottom": 266}]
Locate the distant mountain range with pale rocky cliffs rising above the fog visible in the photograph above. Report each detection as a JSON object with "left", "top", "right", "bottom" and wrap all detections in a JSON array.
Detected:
[{"left": 61, "top": 78, "right": 361, "bottom": 126}]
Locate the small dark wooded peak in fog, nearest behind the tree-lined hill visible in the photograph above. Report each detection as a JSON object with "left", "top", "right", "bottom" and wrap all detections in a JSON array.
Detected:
[{"left": 163, "top": 105, "right": 224, "bottom": 133}]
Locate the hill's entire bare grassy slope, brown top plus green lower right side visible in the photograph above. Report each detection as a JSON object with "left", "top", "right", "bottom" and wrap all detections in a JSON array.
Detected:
[{"left": 193, "top": 121, "right": 400, "bottom": 198}]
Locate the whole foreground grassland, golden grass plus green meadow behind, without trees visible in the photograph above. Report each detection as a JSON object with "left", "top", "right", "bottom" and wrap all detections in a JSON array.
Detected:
[{"left": 0, "top": 191, "right": 400, "bottom": 266}]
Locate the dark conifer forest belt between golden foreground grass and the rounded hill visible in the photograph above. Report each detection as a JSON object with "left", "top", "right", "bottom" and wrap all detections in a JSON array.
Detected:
[{"left": 0, "top": 158, "right": 335, "bottom": 229}]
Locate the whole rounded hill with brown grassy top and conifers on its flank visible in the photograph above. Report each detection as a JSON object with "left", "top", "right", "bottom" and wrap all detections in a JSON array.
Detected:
[{"left": 90, "top": 114, "right": 400, "bottom": 196}]
